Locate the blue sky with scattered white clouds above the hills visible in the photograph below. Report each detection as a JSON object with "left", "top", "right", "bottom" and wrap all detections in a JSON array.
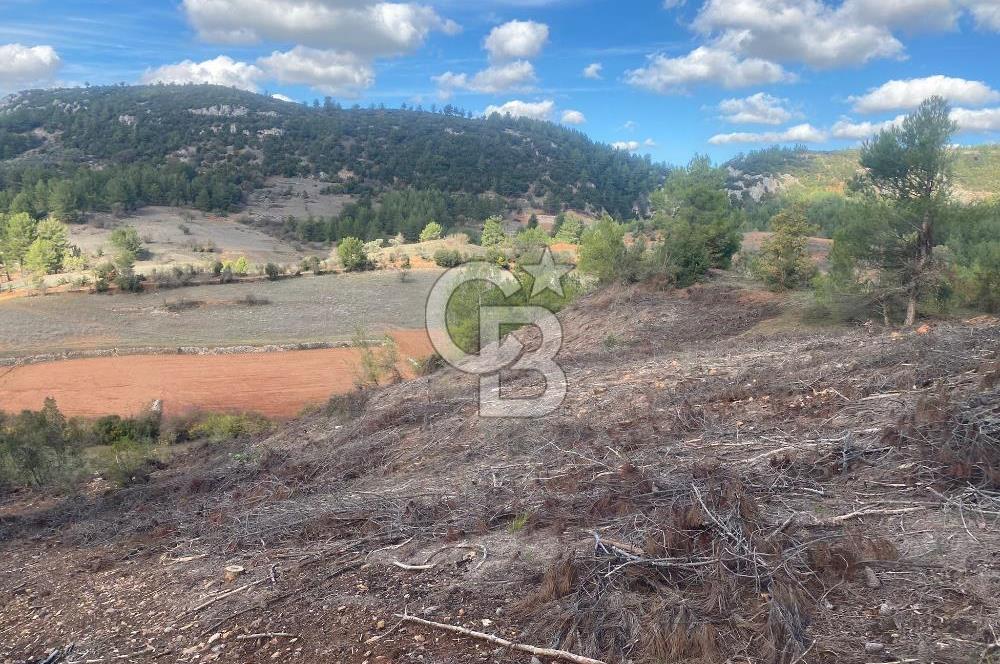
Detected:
[{"left": 0, "top": 0, "right": 1000, "bottom": 163}]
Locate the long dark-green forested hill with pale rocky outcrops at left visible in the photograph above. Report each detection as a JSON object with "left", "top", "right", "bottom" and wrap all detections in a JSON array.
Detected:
[{"left": 0, "top": 85, "right": 666, "bottom": 217}]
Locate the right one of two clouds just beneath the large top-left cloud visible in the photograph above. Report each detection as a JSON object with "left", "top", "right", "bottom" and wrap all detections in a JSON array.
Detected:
[{"left": 257, "top": 46, "right": 375, "bottom": 96}]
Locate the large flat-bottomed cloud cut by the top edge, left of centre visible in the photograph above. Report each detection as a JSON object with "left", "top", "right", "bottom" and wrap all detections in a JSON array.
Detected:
[{"left": 183, "top": 0, "right": 460, "bottom": 57}]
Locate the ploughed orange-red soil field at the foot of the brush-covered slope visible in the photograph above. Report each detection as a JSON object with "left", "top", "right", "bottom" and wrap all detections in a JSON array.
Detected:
[{"left": 0, "top": 330, "right": 431, "bottom": 418}]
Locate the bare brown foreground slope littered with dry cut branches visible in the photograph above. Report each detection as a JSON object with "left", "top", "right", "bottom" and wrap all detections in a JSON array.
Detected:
[{"left": 0, "top": 282, "right": 1000, "bottom": 664}]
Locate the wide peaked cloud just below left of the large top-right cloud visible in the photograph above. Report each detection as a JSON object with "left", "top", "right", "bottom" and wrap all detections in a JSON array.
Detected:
[{"left": 625, "top": 46, "right": 794, "bottom": 93}]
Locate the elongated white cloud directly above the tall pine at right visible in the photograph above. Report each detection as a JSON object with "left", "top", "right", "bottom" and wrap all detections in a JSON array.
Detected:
[{"left": 850, "top": 76, "right": 1000, "bottom": 113}]
